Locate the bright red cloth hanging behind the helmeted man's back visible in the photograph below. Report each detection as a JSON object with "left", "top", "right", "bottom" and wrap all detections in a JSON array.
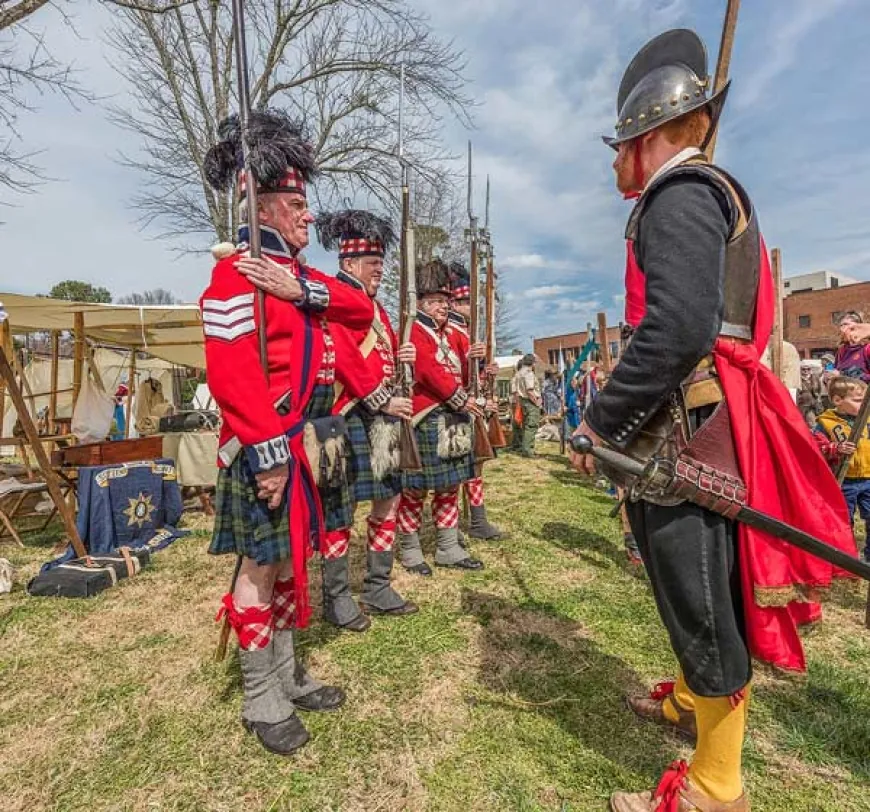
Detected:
[{"left": 713, "top": 240, "right": 857, "bottom": 671}]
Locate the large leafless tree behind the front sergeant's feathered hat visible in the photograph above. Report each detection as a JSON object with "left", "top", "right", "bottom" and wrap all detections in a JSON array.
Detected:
[{"left": 104, "top": 0, "right": 471, "bottom": 247}]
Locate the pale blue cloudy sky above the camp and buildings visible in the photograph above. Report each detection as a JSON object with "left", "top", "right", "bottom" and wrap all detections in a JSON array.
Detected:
[{"left": 0, "top": 0, "right": 870, "bottom": 346}]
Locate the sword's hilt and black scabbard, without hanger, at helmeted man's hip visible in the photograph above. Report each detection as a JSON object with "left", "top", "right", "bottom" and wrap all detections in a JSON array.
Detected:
[{"left": 571, "top": 435, "right": 870, "bottom": 581}]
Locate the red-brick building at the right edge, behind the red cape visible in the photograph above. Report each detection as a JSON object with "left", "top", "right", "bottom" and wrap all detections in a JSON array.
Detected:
[{"left": 782, "top": 282, "right": 870, "bottom": 358}]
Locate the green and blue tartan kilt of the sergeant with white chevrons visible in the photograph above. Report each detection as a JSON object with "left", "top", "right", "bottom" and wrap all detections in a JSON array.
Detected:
[{"left": 208, "top": 452, "right": 290, "bottom": 564}]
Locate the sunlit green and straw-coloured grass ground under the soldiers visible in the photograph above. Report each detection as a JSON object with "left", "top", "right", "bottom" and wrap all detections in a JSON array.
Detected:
[{"left": 0, "top": 454, "right": 870, "bottom": 812}]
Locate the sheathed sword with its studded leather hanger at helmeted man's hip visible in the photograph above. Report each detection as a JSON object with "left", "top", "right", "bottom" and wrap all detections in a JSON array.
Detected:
[{"left": 571, "top": 435, "right": 870, "bottom": 581}]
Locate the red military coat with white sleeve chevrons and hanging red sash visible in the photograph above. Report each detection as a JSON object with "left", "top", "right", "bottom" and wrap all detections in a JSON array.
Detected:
[{"left": 200, "top": 228, "right": 374, "bottom": 626}]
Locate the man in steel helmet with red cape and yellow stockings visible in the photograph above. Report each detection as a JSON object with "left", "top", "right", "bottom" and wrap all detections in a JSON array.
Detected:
[{"left": 577, "top": 30, "right": 855, "bottom": 812}]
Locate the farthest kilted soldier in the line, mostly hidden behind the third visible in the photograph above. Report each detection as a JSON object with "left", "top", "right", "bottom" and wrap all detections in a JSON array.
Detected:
[{"left": 447, "top": 262, "right": 502, "bottom": 541}]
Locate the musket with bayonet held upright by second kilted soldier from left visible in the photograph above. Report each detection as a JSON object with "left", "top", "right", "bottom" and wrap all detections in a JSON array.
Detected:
[{"left": 396, "top": 65, "right": 423, "bottom": 472}]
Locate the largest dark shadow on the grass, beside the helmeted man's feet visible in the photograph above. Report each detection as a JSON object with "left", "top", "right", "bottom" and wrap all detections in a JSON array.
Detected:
[{"left": 462, "top": 589, "right": 675, "bottom": 782}]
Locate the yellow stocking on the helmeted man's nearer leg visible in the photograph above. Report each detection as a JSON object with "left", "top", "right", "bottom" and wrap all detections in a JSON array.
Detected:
[{"left": 689, "top": 685, "right": 749, "bottom": 803}]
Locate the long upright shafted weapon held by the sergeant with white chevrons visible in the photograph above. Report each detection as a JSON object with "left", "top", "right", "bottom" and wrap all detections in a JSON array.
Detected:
[{"left": 215, "top": 0, "right": 269, "bottom": 661}]
